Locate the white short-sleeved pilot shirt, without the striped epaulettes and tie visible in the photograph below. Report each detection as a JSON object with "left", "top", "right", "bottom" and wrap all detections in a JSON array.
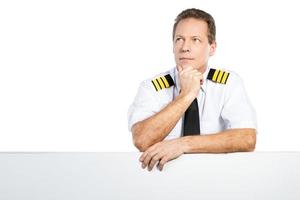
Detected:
[{"left": 128, "top": 67, "right": 257, "bottom": 140}]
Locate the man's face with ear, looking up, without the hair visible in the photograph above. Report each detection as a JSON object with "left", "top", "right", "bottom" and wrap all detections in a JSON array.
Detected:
[{"left": 173, "top": 18, "right": 216, "bottom": 70}]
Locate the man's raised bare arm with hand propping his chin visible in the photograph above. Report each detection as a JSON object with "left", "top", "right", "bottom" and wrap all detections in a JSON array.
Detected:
[{"left": 131, "top": 67, "right": 203, "bottom": 151}]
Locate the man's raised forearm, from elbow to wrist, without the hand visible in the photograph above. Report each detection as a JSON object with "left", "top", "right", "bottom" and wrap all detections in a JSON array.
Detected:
[{"left": 132, "top": 95, "right": 193, "bottom": 151}]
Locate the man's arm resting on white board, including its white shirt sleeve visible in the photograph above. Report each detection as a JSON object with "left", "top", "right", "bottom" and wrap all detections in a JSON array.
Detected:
[{"left": 140, "top": 69, "right": 256, "bottom": 170}]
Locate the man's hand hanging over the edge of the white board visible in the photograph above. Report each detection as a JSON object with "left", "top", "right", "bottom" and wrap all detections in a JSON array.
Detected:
[{"left": 139, "top": 138, "right": 184, "bottom": 171}]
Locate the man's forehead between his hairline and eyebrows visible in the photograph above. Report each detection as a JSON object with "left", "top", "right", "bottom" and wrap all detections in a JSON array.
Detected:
[{"left": 175, "top": 18, "right": 208, "bottom": 36}]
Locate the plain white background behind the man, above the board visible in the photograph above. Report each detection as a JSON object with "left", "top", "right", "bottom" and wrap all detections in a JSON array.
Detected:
[{"left": 0, "top": 0, "right": 300, "bottom": 151}]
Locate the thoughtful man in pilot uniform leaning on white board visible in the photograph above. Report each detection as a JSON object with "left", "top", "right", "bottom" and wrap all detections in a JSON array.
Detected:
[{"left": 128, "top": 9, "right": 257, "bottom": 171}]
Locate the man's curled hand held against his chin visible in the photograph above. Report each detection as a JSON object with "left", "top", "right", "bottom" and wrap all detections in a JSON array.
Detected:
[{"left": 178, "top": 66, "right": 203, "bottom": 100}]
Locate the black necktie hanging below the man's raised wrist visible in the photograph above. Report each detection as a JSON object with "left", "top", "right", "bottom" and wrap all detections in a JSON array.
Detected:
[{"left": 183, "top": 98, "right": 200, "bottom": 136}]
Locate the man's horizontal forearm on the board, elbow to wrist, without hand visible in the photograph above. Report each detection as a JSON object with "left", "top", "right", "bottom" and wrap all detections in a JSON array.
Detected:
[{"left": 179, "top": 128, "right": 256, "bottom": 153}]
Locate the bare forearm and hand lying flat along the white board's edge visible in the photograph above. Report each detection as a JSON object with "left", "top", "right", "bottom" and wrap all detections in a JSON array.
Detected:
[{"left": 139, "top": 128, "right": 256, "bottom": 171}]
